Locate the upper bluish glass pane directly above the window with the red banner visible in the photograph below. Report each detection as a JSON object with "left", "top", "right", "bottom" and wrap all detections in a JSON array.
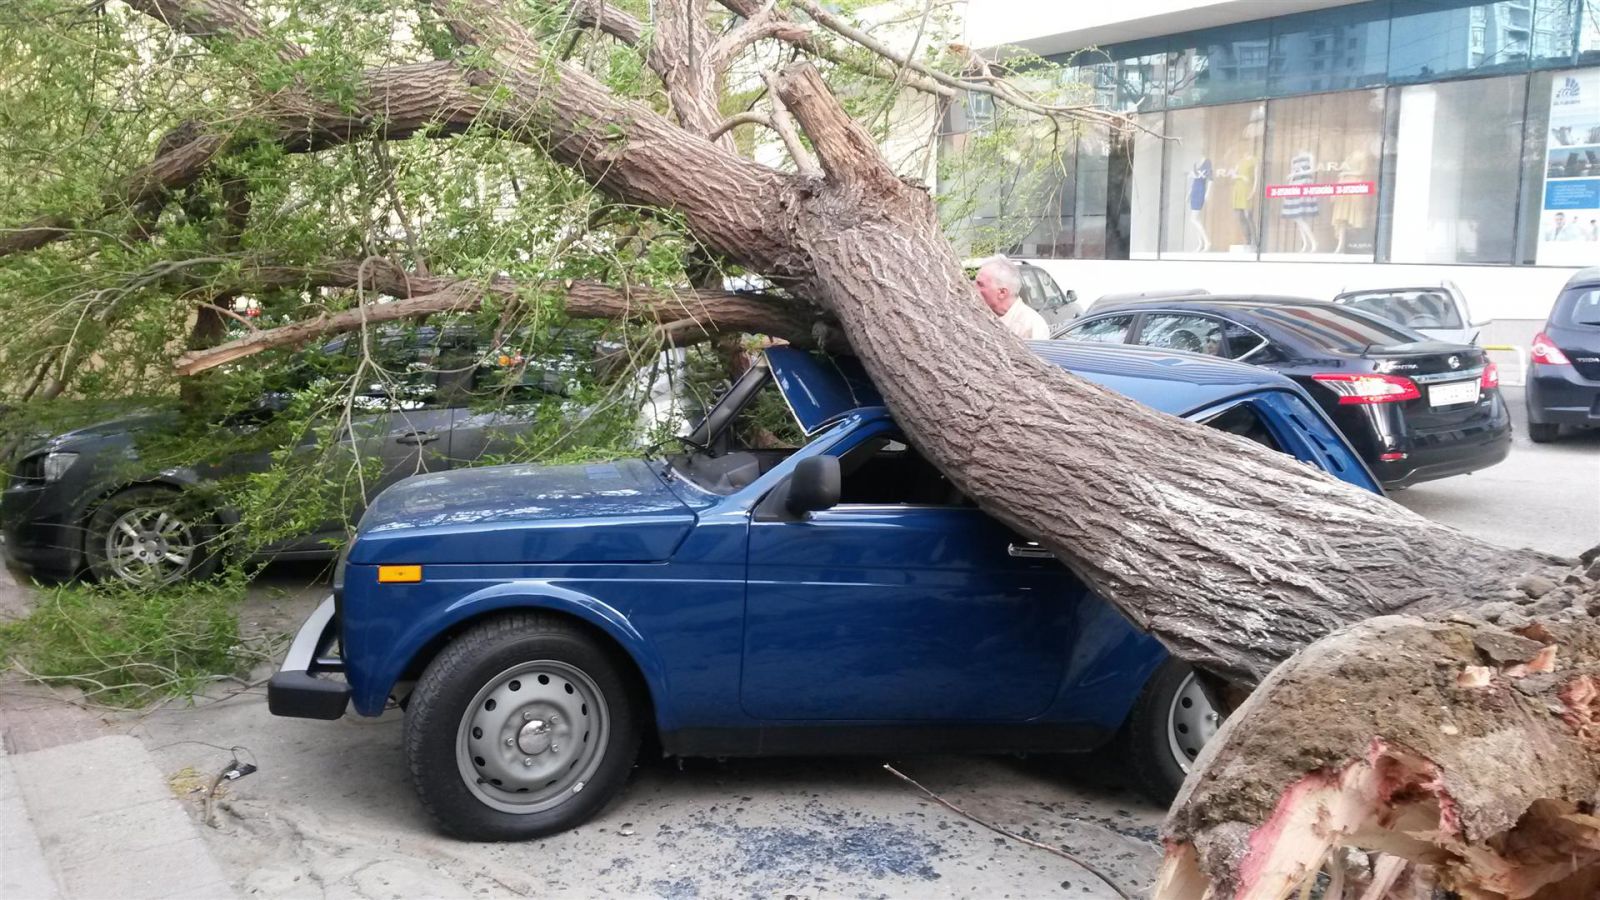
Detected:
[{"left": 1267, "top": 3, "right": 1389, "bottom": 96}]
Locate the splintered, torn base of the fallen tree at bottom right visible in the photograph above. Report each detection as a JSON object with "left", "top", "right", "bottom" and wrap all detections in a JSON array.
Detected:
[{"left": 1155, "top": 551, "right": 1600, "bottom": 900}]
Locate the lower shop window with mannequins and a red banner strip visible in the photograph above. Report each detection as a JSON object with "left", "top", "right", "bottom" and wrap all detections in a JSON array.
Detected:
[{"left": 1262, "top": 90, "right": 1384, "bottom": 261}]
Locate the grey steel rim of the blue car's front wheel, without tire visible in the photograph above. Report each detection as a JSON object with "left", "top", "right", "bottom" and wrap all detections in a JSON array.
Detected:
[{"left": 456, "top": 650, "right": 611, "bottom": 815}]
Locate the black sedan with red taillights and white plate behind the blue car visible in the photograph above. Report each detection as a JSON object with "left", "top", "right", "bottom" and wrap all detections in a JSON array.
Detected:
[{"left": 1056, "top": 295, "right": 1510, "bottom": 487}]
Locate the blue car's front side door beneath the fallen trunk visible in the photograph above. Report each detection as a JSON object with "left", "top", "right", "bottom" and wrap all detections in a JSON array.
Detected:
[{"left": 741, "top": 429, "right": 1085, "bottom": 722}]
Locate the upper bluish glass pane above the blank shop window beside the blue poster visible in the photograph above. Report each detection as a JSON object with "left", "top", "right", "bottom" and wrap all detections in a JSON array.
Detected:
[{"left": 1389, "top": 0, "right": 1534, "bottom": 82}]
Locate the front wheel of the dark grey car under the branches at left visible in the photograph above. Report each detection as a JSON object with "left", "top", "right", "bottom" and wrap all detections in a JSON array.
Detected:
[{"left": 83, "top": 485, "right": 221, "bottom": 588}]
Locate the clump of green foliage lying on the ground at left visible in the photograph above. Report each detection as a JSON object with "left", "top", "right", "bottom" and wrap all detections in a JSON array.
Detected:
[{"left": 0, "top": 578, "right": 254, "bottom": 706}]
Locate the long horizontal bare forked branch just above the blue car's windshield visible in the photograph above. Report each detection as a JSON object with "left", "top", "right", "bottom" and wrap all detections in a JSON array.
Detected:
[{"left": 178, "top": 259, "right": 826, "bottom": 375}]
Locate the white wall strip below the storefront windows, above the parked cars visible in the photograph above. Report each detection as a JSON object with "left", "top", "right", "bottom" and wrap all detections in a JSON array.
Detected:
[{"left": 1030, "top": 259, "right": 1578, "bottom": 322}]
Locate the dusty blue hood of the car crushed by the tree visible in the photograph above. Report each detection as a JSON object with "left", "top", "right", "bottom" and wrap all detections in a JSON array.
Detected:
[{"left": 349, "top": 460, "right": 694, "bottom": 564}]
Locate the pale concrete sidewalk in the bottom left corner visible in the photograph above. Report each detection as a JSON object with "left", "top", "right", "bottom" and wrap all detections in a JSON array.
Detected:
[{"left": 0, "top": 735, "right": 234, "bottom": 900}]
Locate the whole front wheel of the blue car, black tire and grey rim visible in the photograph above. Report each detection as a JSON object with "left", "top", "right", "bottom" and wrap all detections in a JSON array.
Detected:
[{"left": 405, "top": 613, "right": 640, "bottom": 841}]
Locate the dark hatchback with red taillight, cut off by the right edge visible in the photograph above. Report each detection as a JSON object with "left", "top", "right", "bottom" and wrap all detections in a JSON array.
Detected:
[{"left": 1526, "top": 269, "right": 1600, "bottom": 444}]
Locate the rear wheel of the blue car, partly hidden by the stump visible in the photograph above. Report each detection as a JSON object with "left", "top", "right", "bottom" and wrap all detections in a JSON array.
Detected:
[{"left": 1118, "top": 658, "right": 1221, "bottom": 806}]
